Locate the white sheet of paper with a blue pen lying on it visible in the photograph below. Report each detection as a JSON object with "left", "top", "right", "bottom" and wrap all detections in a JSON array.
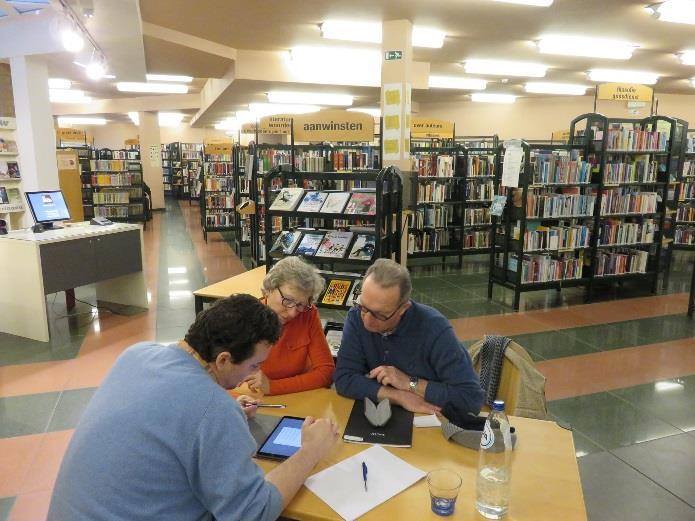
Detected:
[{"left": 304, "top": 445, "right": 425, "bottom": 521}]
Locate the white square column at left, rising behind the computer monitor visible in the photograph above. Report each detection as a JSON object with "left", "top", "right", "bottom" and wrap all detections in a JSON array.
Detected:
[{"left": 10, "top": 56, "right": 60, "bottom": 192}]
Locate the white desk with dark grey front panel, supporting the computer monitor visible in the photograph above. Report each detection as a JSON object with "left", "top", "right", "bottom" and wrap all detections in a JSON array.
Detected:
[{"left": 0, "top": 222, "right": 148, "bottom": 342}]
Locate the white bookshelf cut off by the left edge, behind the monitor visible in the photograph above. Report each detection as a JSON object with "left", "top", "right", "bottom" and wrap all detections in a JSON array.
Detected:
[{"left": 0, "top": 118, "right": 25, "bottom": 231}]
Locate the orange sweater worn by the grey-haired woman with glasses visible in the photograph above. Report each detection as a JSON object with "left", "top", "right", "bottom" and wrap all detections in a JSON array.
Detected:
[{"left": 261, "top": 308, "right": 335, "bottom": 394}]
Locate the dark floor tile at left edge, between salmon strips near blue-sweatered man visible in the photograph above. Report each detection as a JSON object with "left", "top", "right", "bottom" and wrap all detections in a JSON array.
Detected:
[{"left": 0, "top": 392, "right": 60, "bottom": 438}]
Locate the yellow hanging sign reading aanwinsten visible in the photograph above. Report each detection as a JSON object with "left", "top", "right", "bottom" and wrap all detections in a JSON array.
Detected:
[{"left": 294, "top": 109, "right": 374, "bottom": 142}]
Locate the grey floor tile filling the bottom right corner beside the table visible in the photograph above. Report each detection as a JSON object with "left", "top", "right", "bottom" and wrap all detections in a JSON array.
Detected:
[{"left": 578, "top": 452, "right": 695, "bottom": 521}]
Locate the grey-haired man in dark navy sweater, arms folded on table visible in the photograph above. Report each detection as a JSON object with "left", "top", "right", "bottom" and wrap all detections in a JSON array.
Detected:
[{"left": 335, "top": 259, "right": 484, "bottom": 424}]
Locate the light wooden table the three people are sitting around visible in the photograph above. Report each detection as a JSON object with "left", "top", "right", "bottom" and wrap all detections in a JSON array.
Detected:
[{"left": 257, "top": 389, "right": 587, "bottom": 521}]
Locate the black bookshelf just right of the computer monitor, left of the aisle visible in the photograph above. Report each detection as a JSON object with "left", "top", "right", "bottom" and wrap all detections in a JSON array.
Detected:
[{"left": 90, "top": 148, "right": 146, "bottom": 224}]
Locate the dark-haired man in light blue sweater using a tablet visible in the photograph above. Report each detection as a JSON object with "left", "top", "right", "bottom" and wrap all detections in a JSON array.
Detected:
[{"left": 48, "top": 295, "right": 338, "bottom": 521}]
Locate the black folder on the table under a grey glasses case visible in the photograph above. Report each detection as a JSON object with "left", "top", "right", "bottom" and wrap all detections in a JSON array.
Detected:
[{"left": 343, "top": 400, "right": 414, "bottom": 447}]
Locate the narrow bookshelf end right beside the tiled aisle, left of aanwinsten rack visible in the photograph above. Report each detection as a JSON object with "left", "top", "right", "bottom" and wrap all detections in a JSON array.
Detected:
[{"left": 200, "top": 145, "right": 236, "bottom": 242}]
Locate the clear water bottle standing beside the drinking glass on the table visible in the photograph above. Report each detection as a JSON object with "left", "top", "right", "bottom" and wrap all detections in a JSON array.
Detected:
[{"left": 476, "top": 400, "right": 512, "bottom": 519}]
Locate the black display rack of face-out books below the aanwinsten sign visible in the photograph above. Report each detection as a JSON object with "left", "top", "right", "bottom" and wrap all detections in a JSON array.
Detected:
[{"left": 263, "top": 166, "right": 402, "bottom": 309}]
